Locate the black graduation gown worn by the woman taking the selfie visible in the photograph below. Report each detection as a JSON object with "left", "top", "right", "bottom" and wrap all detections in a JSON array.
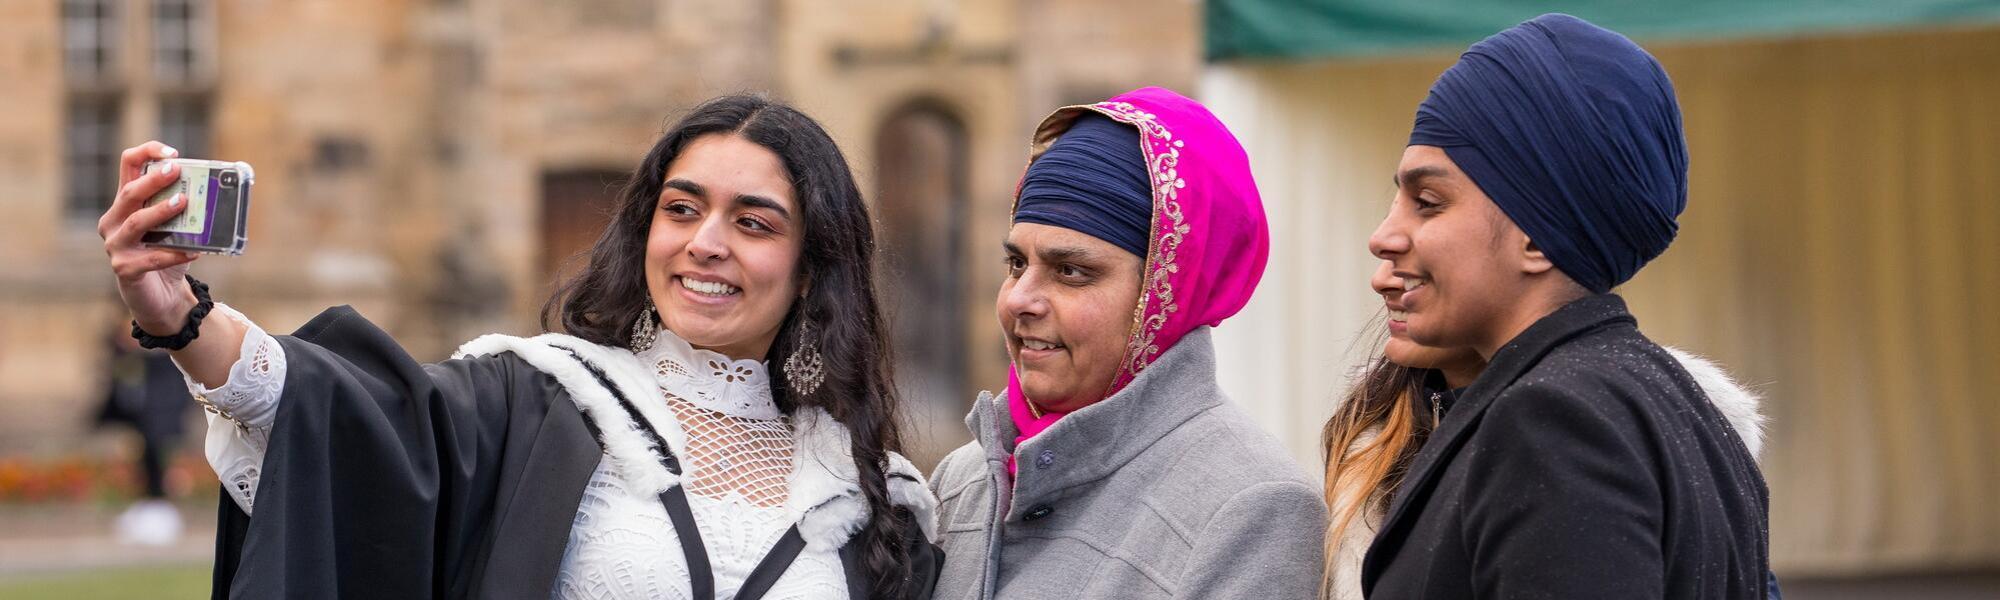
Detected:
[{"left": 214, "top": 306, "right": 942, "bottom": 600}]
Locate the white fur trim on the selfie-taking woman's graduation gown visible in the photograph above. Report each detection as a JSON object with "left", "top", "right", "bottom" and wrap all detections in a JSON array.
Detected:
[{"left": 454, "top": 334, "right": 938, "bottom": 548}]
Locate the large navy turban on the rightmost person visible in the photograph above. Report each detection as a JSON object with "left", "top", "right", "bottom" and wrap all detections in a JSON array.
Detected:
[{"left": 1410, "top": 14, "right": 1688, "bottom": 292}]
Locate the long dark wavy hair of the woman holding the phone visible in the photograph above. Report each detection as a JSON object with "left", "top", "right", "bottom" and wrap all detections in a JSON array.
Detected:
[{"left": 542, "top": 96, "right": 916, "bottom": 598}]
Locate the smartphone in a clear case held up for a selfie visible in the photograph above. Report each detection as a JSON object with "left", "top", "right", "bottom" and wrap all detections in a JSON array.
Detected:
[{"left": 140, "top": 158, "right": 256, "bottom": 256}]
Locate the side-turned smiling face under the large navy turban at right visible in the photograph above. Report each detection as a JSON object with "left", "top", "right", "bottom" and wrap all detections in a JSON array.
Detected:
[{"left": 1368, "top": 146, "right": 1552, "bottom": 356}]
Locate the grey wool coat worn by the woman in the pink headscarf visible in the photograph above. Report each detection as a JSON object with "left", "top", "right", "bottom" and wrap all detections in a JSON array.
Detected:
[{"left": 930, "top": 328, "right": 1326, "bottom": 600}]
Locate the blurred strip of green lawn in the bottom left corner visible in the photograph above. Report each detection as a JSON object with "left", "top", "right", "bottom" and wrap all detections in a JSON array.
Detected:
[{"left": 0, "top": 564, "right": 210, "bottom": 600}]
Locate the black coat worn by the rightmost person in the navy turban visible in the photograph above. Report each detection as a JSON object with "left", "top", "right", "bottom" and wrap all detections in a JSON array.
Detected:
[{"left": 1362, "top": 294, "right": 1770, "bottom": 600}]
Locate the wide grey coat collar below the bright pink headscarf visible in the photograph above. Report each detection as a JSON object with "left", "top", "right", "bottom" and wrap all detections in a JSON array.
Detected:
[{"left": 966, "top": 326, "right": 1222, "bottom": 520}]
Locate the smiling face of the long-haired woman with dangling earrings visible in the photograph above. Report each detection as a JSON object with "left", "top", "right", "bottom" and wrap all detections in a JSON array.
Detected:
[{"left": 646, "top": 134, "right": 804, "bottom": 360}]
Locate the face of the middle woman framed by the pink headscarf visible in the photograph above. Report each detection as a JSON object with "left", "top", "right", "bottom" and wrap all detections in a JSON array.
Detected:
[{"left": 994, "top": 222, "right": 1144, "bottom": 412}]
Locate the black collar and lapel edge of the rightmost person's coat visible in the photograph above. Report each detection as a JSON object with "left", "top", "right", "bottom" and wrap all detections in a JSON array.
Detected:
[{"left": 1362, "top": 294, "right": 1638, "bottom": 588}]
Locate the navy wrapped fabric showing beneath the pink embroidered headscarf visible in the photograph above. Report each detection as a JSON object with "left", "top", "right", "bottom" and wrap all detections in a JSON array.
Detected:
[{"left": 1014, "top": 114, "right": 1152, "bottom": 258}]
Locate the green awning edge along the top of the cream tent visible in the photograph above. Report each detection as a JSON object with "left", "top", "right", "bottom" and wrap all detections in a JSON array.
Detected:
[{"left": 1206, "top": 0, "right": 2000, "bottom": 60}]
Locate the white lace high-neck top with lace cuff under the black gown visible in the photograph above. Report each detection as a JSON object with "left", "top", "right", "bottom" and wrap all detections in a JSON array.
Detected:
[{"left": 188, "top": 304, "right": 934, "bottom": 600}]
